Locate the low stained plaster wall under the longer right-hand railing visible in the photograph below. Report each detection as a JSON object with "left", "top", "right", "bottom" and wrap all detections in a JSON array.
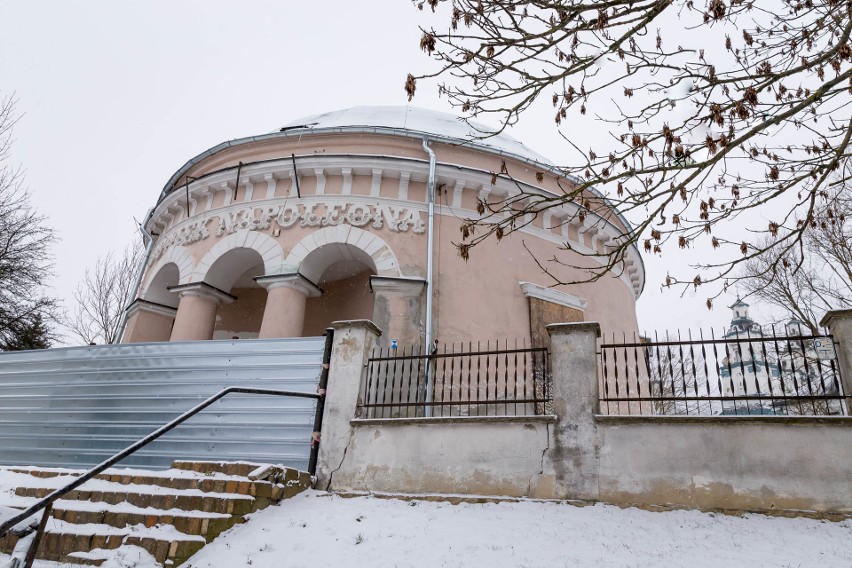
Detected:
[{"left": 598, "top": 416, "right": 852, "bottom": 513}]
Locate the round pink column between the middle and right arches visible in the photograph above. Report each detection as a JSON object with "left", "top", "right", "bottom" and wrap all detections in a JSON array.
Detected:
[{"left": 254, "top": 273, "right": 322, "bottom": 339}]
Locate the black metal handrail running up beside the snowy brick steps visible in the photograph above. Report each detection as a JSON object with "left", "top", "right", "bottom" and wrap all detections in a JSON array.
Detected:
[{"left": 0, "top": 387, "right": 325, "bottom": 540}]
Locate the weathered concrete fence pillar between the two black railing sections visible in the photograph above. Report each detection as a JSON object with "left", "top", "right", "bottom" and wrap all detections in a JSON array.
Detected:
[{"left": 530, "top": 322, "right": 601, "bottom": 499}]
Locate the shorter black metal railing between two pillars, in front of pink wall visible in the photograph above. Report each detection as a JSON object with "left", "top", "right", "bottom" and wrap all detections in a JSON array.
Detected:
[{"left": 360, "top": 341, "right": 552, "bottom": 418}]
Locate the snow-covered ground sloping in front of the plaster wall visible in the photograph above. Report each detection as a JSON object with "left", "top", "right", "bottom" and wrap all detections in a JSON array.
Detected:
[{"left": 0, "top": 491, "right": 852, "bottom": 568}]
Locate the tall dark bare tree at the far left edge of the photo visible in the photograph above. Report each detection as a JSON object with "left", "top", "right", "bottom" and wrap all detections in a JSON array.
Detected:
[{"left": 0, "top": 96, "right": 55, "bottom": 350}]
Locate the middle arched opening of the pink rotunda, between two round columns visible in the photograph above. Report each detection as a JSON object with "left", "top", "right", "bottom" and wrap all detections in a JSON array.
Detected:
[{"left": 204, "top": 248, "right": 266, "bottom": 339}]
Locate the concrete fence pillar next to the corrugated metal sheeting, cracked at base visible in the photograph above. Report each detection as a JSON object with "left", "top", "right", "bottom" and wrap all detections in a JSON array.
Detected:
[{"left": 316, "top": 320, "right": 382, "bottom": 489}]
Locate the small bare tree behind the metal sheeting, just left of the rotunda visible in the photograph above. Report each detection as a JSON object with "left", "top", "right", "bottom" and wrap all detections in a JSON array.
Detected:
[{"left": 62, "top": 242, "right": 145, "bottom": 344}]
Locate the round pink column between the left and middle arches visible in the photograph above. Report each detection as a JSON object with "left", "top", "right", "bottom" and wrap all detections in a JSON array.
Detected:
[{"left": 168, "top": 282, "right": 237, "bottom": 341}]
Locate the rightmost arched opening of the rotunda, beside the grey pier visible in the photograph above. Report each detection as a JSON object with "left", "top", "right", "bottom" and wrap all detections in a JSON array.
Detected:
[{"left": 299, "top": 243, "right": 376, "bottom": 337}]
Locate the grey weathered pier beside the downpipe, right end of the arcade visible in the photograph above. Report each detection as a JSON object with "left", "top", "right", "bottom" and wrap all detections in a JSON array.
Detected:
[{"left": 370, "top": 276, "right": 426, "bottom": 347}]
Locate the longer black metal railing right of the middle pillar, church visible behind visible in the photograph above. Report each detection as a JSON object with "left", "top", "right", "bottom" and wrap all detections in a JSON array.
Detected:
[{"left": 599, "top": 328, "right": 850, "bottom": 416}]
